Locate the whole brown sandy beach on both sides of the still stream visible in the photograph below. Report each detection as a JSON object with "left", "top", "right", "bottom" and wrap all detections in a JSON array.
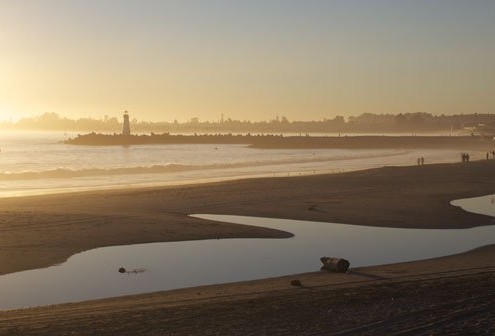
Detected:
[{"left": 0, "top": 160, "right": 495, "bottom": 335}]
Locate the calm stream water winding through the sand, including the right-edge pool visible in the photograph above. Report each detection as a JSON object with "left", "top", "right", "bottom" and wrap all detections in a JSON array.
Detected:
[{"left": 0, "top": 196, "right": 495, "bottom": 308}]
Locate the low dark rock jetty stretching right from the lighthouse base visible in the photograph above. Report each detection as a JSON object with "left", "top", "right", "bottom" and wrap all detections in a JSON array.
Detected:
[{"left": 64, "top": 132, "right": 495, "bottom": 151}]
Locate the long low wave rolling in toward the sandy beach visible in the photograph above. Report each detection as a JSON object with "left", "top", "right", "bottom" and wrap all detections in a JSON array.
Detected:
[{"left": 0, "top": 151, "right": 408, "bottom": 181}]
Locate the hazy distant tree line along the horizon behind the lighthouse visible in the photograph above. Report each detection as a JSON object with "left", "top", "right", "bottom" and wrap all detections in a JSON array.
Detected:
[{"left": 0, "top": 112, "right": 495, "bottom": 134}]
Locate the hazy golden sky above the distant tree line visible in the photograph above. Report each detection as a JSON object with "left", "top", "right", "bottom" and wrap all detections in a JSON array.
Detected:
[{"left": 0, "top": 0, "right": 495, "bottom": 120}]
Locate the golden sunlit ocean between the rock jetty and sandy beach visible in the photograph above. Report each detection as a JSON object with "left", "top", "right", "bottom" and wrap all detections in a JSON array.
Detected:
[{"left": 0, "top": 131, "right": 485, "bottom": 197}]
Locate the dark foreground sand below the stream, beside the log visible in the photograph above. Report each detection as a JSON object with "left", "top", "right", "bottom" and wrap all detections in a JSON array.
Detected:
[{"left": 0, "top": 245, "right": 495, "bottom": 336}]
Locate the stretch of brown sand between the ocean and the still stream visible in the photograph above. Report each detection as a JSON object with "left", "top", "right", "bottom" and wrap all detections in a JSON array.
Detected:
[{"left": 0, "top": 160, "right": 495, "bottom": 275}]
